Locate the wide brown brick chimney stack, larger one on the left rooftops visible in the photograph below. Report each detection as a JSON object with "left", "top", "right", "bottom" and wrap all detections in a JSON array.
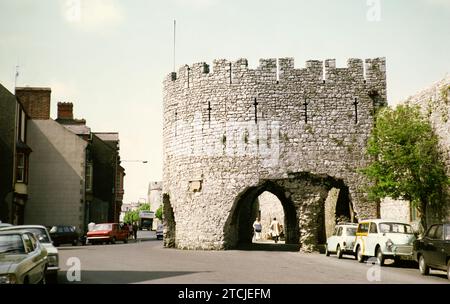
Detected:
[{"left": 16, "top": 87, "right": 52, "bottom": 120}]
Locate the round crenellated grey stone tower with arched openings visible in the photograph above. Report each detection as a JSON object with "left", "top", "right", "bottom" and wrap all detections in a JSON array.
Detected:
[{"left": 163, "top": 58, "right": 386, "bottom": 250}]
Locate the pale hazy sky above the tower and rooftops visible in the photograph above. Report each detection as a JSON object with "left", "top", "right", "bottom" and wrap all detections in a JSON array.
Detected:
[{"left": 0, "top": 0, "right": 450, "bottom": 202}]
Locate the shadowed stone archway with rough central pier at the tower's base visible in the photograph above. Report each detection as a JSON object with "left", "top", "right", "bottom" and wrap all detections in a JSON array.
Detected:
[{"left": 224, "top": 172, "right": 351, "bottom": 251}]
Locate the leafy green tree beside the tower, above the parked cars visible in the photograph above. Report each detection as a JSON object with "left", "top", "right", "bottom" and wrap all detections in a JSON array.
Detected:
[{"left": 362, "top": 105, "right": 450, "bottom": 229}]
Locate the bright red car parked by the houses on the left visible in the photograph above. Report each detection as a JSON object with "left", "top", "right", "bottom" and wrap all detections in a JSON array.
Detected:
[{"left": 86, "top": 223, "right": 129, "bottom": 244}]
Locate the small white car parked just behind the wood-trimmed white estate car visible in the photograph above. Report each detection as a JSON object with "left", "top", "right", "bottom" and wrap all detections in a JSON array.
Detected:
[{"left": 325, "top": 223, "right": 358, "bottom": 259}]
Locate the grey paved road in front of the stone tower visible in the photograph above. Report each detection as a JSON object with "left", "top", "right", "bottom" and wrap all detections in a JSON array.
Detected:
[{"left": 59, "top": 231, "right": 450, "bottom": 284}]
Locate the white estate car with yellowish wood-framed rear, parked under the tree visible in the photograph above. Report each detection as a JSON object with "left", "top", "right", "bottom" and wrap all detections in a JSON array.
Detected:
[{"left": 354, "top": 219, "right": 416, "bottom": 266}]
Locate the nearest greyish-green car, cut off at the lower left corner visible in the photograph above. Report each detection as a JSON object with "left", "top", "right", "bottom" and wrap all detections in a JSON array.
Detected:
[{"left": 0, "top": 230, "right": 48, "bottom": 284}]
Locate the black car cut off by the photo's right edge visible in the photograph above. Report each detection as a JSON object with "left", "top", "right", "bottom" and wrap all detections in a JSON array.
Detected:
[{"left": 414, "top": 223, "right": 450, "bottom": 280}]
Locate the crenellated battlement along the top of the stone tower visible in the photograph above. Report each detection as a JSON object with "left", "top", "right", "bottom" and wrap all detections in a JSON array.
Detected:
[{"left": 166, "top": 57, "right": 386, "bottom": 88}]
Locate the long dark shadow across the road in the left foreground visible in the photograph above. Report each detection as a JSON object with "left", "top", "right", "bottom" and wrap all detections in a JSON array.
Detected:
[{"left": 58, "top": 270, "right": 204, "bottom": 284}]
